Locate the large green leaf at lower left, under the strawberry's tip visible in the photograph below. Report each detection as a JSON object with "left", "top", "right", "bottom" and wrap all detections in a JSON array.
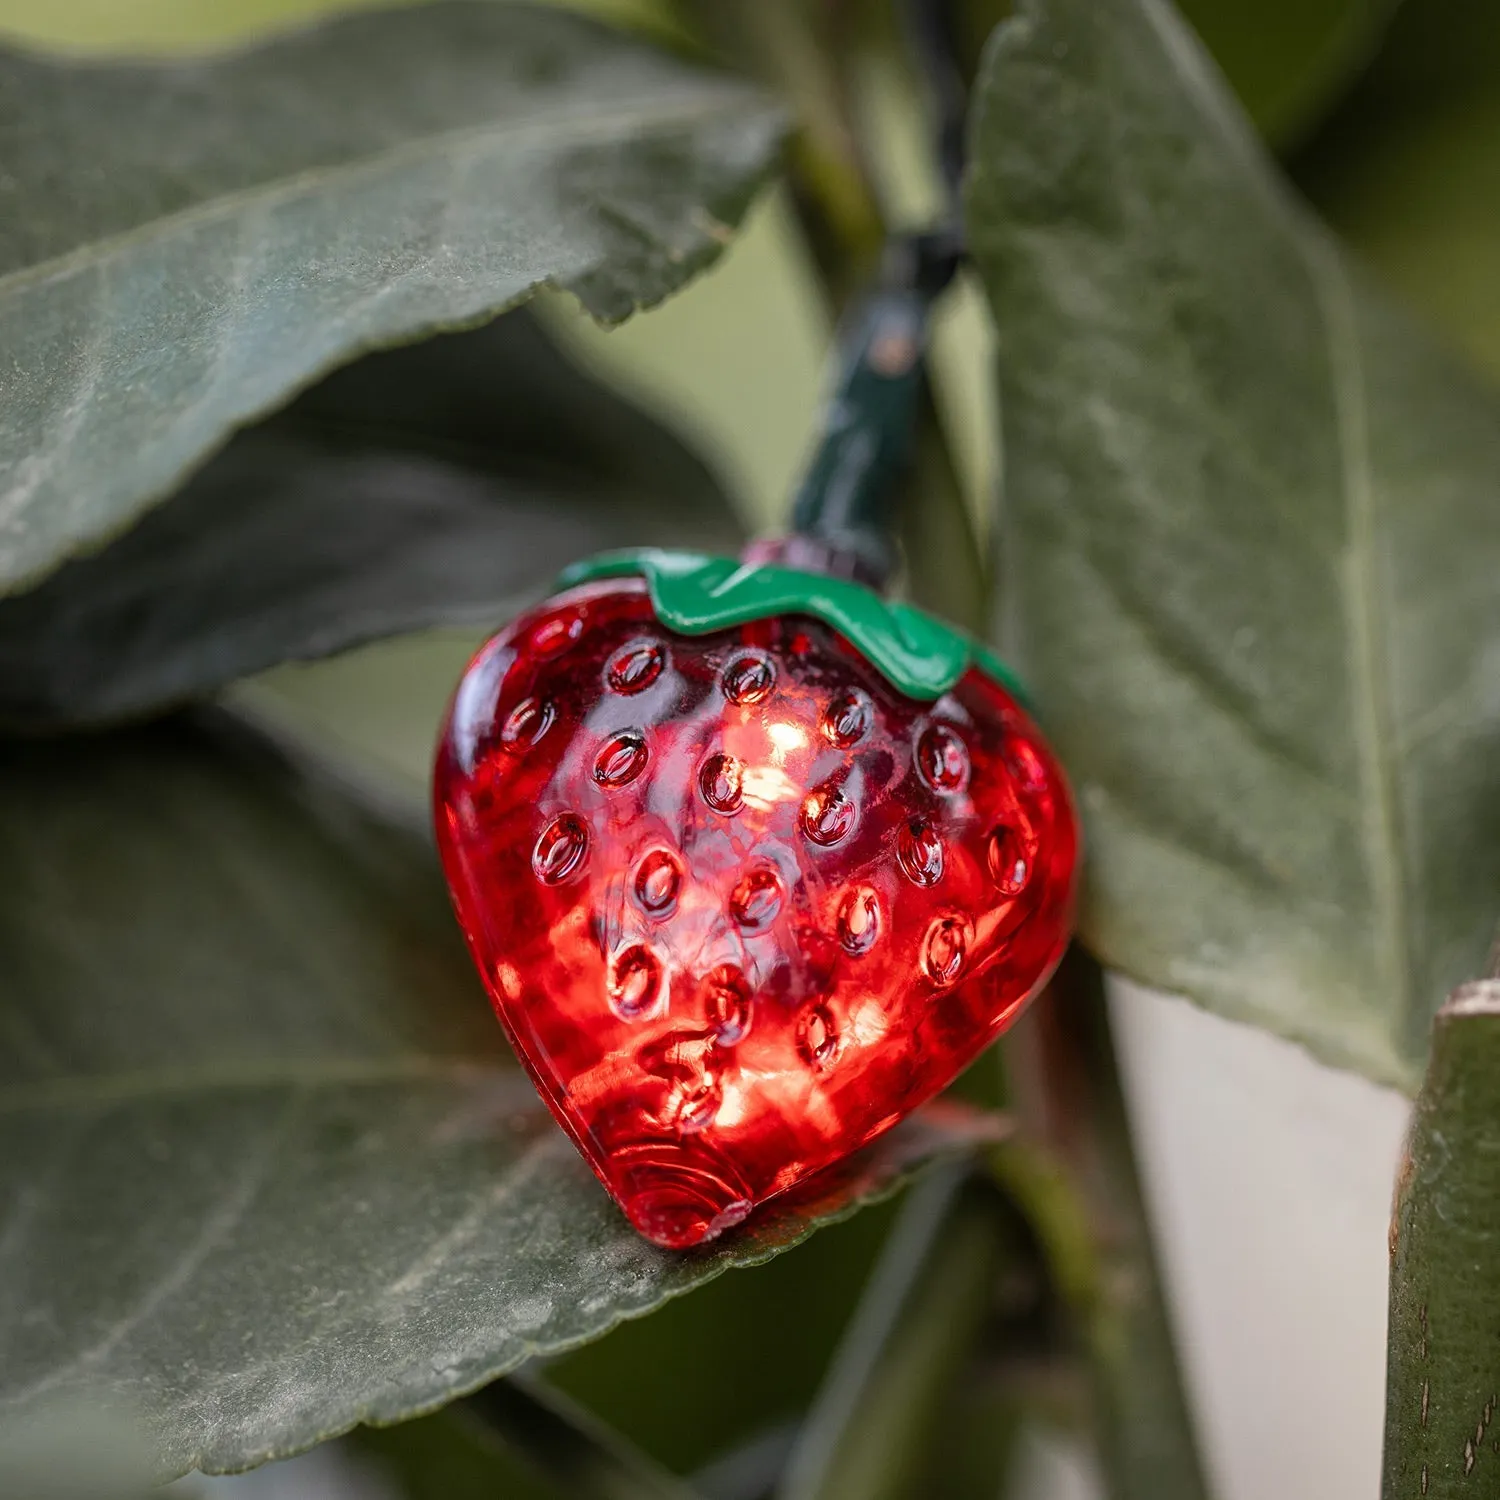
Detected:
[{"left": 0, "top": 711, "right": 1008, "bottom": 1473}]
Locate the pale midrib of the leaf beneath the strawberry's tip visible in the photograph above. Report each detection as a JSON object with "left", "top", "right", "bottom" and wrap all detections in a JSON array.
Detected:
[{"left": 0, "top": 1053, "right": 533, "bottom": 1116}]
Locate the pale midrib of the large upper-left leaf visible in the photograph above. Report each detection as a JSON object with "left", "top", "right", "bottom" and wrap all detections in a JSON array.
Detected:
[{"left": 0, "top": 84, "right": 764, "bottom": 297}]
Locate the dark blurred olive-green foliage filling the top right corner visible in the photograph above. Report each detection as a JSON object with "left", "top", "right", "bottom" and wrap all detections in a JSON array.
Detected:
[{"left": 1293, "top": 0, "right": 1500, "bottom": 377}]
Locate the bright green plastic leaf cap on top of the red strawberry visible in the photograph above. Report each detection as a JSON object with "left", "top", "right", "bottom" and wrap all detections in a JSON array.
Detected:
[{"left": 558, "top": 548, "right": 1026, "bottom": 704}]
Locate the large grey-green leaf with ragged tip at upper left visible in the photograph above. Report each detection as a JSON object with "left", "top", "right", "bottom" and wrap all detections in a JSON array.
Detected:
[{"left": 0, "top": 0, "right": 780, "bottom": 593}]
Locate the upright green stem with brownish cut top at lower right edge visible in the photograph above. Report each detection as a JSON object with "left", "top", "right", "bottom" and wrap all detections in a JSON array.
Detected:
[{"left": 1382, "top": 978, "right": 1500, "bottom": 1500}]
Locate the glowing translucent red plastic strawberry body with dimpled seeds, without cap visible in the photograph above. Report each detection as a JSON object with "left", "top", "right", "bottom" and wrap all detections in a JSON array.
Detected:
[{"left": 435, "top": 578, "right": 1079, "bottom": 1248}]
